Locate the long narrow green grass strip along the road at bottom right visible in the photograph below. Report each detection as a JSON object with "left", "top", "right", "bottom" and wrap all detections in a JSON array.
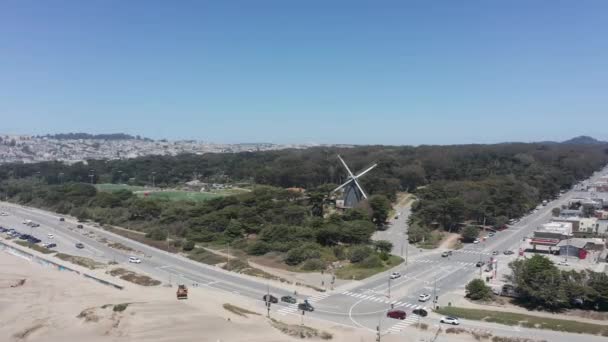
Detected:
[{"left": 436, "top": 306, "right": 608, "bottom": 336}]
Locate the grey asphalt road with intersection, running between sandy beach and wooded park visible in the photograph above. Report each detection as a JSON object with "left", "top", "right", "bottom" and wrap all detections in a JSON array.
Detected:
[{"left": 0, "top": 164, "right": 606, "bottom": 341}]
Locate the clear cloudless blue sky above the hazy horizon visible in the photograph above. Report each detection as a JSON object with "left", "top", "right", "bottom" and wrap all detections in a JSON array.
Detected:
[{"left": 0, "top": 0, "right": 608, "bottom": 144}]
